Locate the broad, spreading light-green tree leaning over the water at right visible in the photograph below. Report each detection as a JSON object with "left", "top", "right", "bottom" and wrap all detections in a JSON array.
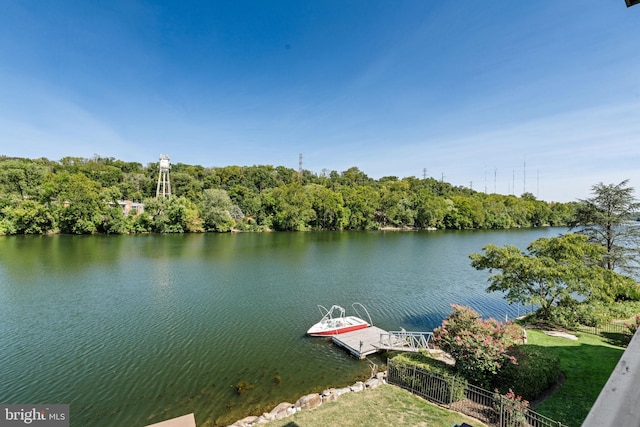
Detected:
[{"left": 470, "top": 234, "right": 610, "bottom": 319}]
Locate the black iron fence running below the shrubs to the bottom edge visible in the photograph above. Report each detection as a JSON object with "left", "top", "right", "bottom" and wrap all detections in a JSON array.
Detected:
[{"left": 387, "top": 360, "right": 566, "bottom": 427}]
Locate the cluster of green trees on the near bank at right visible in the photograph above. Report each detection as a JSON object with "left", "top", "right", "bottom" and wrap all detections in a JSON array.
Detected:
[{"left": 470, "top": 180, "right": 640, "bottom": 332}]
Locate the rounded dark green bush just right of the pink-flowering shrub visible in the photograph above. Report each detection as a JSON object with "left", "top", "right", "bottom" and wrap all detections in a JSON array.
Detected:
[{"left": 493, "top": 345, "right": 560, "bottom": 400}]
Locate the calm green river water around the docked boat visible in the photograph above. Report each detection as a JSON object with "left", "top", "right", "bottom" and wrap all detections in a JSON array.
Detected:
[{"left": 0, "top": 228, "right": 565, "bottom": 427}]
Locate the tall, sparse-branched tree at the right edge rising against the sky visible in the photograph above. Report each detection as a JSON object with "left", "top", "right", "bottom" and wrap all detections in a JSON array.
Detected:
[{"left": 572, "top": 180, "right": 640, "bottom": 271}]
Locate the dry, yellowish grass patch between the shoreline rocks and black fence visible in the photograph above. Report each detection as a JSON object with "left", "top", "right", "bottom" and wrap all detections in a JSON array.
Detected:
[{"left": 268, "top": 384, "right": 484, "bottom": 427}]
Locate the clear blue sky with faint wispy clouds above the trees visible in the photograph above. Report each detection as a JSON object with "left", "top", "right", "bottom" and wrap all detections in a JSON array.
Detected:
[{"left": 0, "top": 0, "right": 640, "bottom": 201}]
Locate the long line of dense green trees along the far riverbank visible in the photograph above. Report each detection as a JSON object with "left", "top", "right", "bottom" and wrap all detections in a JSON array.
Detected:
[{"left": 0, "top": 155, "right": 578, "bottom": 234}]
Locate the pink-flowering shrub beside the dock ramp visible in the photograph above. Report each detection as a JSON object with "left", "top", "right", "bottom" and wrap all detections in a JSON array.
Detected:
[{"left": 433, "top": 304, "right": 521, "bottom": 387}]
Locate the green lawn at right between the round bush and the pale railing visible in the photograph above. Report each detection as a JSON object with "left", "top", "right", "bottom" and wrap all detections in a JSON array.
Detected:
[{"left": 527, "top": 330, "right": 624, "bottom": 426}]
